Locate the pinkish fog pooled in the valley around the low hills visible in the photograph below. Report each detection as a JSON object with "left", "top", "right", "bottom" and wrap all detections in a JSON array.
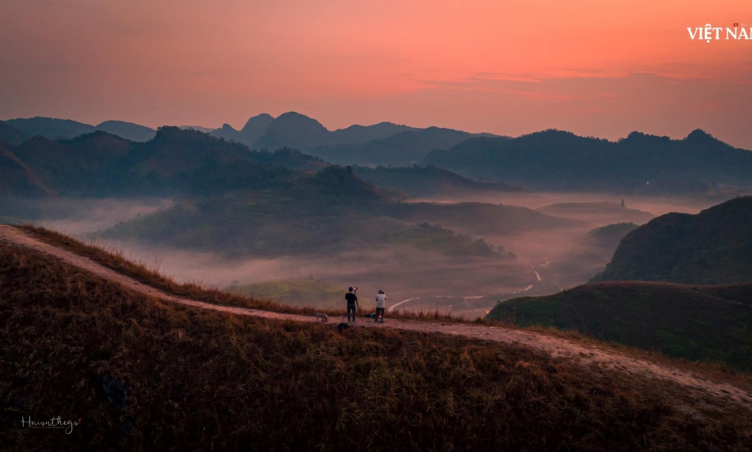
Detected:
[{"left": 0, "top": 193, "right": 720, "bottom": 317}]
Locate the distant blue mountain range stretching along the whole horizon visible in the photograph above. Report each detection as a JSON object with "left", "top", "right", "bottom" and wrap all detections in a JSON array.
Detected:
[{"left": 0, "top": 112, "right": 752, "bottom": 195}]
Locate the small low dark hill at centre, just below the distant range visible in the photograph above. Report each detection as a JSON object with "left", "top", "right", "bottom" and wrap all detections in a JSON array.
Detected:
[{"left": 353, "top": 165, "right": 525, "bottom": 197}]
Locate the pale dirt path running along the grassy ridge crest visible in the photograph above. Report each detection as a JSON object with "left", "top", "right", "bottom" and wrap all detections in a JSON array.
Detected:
[{"left": 0, "top": 225, "right": 752, "bottom": 409}]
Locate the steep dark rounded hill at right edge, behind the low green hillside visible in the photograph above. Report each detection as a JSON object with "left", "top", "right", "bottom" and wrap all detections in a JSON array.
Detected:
[{"left": 594, "top": 196, "right": 752, "bottom": 284}]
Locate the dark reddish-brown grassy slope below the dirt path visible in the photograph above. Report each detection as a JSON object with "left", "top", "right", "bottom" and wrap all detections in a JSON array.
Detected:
[{"left": 0, "top": 243, "right": 752, "bottom": 451}]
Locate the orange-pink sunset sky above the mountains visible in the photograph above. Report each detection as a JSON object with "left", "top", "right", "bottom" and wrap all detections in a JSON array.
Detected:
[{"left": 0, "top": 0, "right": 752, "bottom": 149}]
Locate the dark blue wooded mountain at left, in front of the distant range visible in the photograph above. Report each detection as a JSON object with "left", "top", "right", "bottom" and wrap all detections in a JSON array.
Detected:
[{"left": 4, "top": 127, "right": 326, "bottom": 196}]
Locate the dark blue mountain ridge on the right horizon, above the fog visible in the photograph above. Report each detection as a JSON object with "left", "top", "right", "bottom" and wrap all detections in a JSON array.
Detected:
[{"left": 423, "top": 130, "right": 752, "bottom": 193}]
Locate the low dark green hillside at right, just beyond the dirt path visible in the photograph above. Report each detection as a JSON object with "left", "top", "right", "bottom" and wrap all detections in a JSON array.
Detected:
[{"left": 487, "top": 282, "right": 752, "bottom": 371}]
